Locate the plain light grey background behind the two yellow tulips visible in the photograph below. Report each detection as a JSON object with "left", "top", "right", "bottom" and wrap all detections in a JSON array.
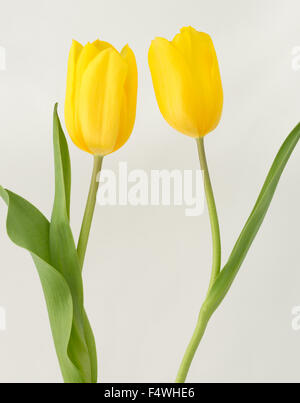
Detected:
[{"left": 0, "top": 0, "right": 300, "bottom": 382}]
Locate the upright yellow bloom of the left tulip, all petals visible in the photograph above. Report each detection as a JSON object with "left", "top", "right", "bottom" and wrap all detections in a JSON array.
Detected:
[{"left": 65, "top": 40, "right": 137, "bottom": 156}]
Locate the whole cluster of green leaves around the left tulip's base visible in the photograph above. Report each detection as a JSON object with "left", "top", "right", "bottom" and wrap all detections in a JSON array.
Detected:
[{"left": 0, "top": 106, "right": 97, "bottom": 383}]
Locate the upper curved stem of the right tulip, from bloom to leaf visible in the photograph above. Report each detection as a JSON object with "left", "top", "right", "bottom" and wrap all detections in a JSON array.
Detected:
[{"left": 196, "top": 137, "right": 221, "bottom": 290}]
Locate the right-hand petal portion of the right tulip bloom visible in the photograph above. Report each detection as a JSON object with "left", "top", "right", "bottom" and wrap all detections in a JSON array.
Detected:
[{"left": 172, "top": 27, "right": 223, "bottom": 136}]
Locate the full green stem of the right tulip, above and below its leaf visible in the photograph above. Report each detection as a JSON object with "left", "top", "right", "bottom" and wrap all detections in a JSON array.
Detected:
[{"left": 176, "top": 137, "right": 221, "bottom": 383}]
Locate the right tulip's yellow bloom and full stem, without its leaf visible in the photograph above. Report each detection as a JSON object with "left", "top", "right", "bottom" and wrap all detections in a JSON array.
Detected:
[{"left": 149, "top": 27, "right": 223, "bottom": 382}]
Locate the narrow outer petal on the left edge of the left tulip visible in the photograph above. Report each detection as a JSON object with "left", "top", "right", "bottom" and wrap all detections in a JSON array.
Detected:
[{"left": 65, "top": 40, "right": 85, "bottom": 150}]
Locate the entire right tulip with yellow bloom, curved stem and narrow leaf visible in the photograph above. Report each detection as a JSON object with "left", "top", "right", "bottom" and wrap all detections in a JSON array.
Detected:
[{"left": 149, "top": 27, "right": 300, "bottom": 383}]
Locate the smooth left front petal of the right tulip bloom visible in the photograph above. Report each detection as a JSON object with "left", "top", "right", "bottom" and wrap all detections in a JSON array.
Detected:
[{"left": 148, "top": 38, "right": 198, "bottom": 137}]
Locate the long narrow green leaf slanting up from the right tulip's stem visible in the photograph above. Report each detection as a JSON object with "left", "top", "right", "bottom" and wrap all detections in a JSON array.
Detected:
[{"left": 203, "top": 123, "right": 300, "bottom": 316}]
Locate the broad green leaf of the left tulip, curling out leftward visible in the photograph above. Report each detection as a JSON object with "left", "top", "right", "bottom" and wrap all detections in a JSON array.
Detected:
[{"left": 0, "top": 186, "right": 83, "bottom": 383}]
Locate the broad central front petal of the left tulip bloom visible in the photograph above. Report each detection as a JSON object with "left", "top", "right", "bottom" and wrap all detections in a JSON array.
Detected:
[{"left": 78, "top": 48, "right": 128, "bottom": 155}]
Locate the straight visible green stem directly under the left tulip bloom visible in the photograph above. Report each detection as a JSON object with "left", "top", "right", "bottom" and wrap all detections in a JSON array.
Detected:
[{"left": 77, "top": 155, "right": 103, "bottom": 270}]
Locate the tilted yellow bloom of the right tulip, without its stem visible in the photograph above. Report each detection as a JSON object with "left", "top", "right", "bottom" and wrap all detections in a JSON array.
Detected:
[{"left": 149, "top": 27, "right": 223, "bottom": 138}]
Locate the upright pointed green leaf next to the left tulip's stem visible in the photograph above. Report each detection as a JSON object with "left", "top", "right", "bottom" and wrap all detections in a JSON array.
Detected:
[{"left": 49, "top": 105, "right": 97, "bottom": 382}]
